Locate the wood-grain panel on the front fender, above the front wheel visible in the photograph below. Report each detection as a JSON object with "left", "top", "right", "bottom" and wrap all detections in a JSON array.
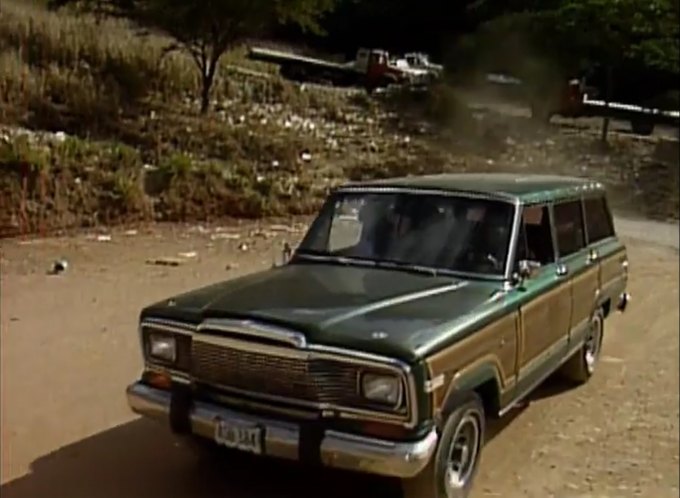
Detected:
[{"left": 426, "top": 312, "right": 518, "bottom": 410}]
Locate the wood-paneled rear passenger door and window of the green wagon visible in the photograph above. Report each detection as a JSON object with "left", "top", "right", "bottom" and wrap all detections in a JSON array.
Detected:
[{"left": 553, "top": 198, "right": 600, "bottom": 349}]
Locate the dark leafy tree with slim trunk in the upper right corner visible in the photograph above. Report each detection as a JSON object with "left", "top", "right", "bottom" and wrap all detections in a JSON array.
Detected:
[{"left": 464, "top": 0, "right": 680, "bottom": 141}]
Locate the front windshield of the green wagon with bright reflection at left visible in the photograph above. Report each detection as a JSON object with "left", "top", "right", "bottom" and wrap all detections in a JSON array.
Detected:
[{"left": 297, "top": 192, "right": 515, "bottom": 276}]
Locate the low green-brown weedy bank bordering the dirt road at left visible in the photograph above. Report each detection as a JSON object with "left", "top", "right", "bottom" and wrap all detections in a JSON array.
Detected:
[{"left": 0, "top": 130, "right": 332, "bottom": 236}]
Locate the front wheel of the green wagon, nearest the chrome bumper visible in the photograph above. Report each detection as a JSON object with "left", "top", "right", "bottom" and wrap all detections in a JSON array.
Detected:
[{"left": 402, "top": 392, "right": 485, "bottom": 498}]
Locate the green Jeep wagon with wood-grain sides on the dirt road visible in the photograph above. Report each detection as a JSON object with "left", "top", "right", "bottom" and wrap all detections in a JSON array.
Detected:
[{"left": 127, "top": 174, "right": 628, "bottom": 498}]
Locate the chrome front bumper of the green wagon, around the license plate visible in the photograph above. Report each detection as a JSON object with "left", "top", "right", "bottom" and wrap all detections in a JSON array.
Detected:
[{"left": 127, "top": 382, "right": 438, "bottom": 478}]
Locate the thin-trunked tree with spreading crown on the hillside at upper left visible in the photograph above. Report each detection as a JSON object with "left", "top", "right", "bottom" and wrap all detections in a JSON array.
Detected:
[{"left": 50, "top": 0, "right": 335, "bottom": 113}]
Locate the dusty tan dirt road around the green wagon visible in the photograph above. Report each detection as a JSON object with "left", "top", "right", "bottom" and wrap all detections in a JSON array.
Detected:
[{"left": 0, "top": 219, "right": 679, "bottom": 498}]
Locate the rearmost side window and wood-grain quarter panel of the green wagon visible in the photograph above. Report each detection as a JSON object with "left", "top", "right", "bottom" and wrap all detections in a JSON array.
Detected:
[{"left": 583, "top": 193, "right": 628, "bottom": 307}]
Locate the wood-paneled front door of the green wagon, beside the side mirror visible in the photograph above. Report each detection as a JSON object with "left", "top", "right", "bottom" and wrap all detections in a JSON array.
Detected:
[{"left": 513, "top": 205, "right": 571, "bottom": 396}]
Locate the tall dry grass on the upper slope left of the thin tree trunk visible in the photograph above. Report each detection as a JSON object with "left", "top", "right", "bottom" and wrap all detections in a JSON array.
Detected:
[{"left": 0, "top": 2, "right": 195, "bottom": 115}]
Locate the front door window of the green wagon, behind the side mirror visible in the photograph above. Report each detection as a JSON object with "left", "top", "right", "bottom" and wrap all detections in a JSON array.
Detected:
[{"left": 515, "top": 206, "right": 555, "bottom": 270}]
